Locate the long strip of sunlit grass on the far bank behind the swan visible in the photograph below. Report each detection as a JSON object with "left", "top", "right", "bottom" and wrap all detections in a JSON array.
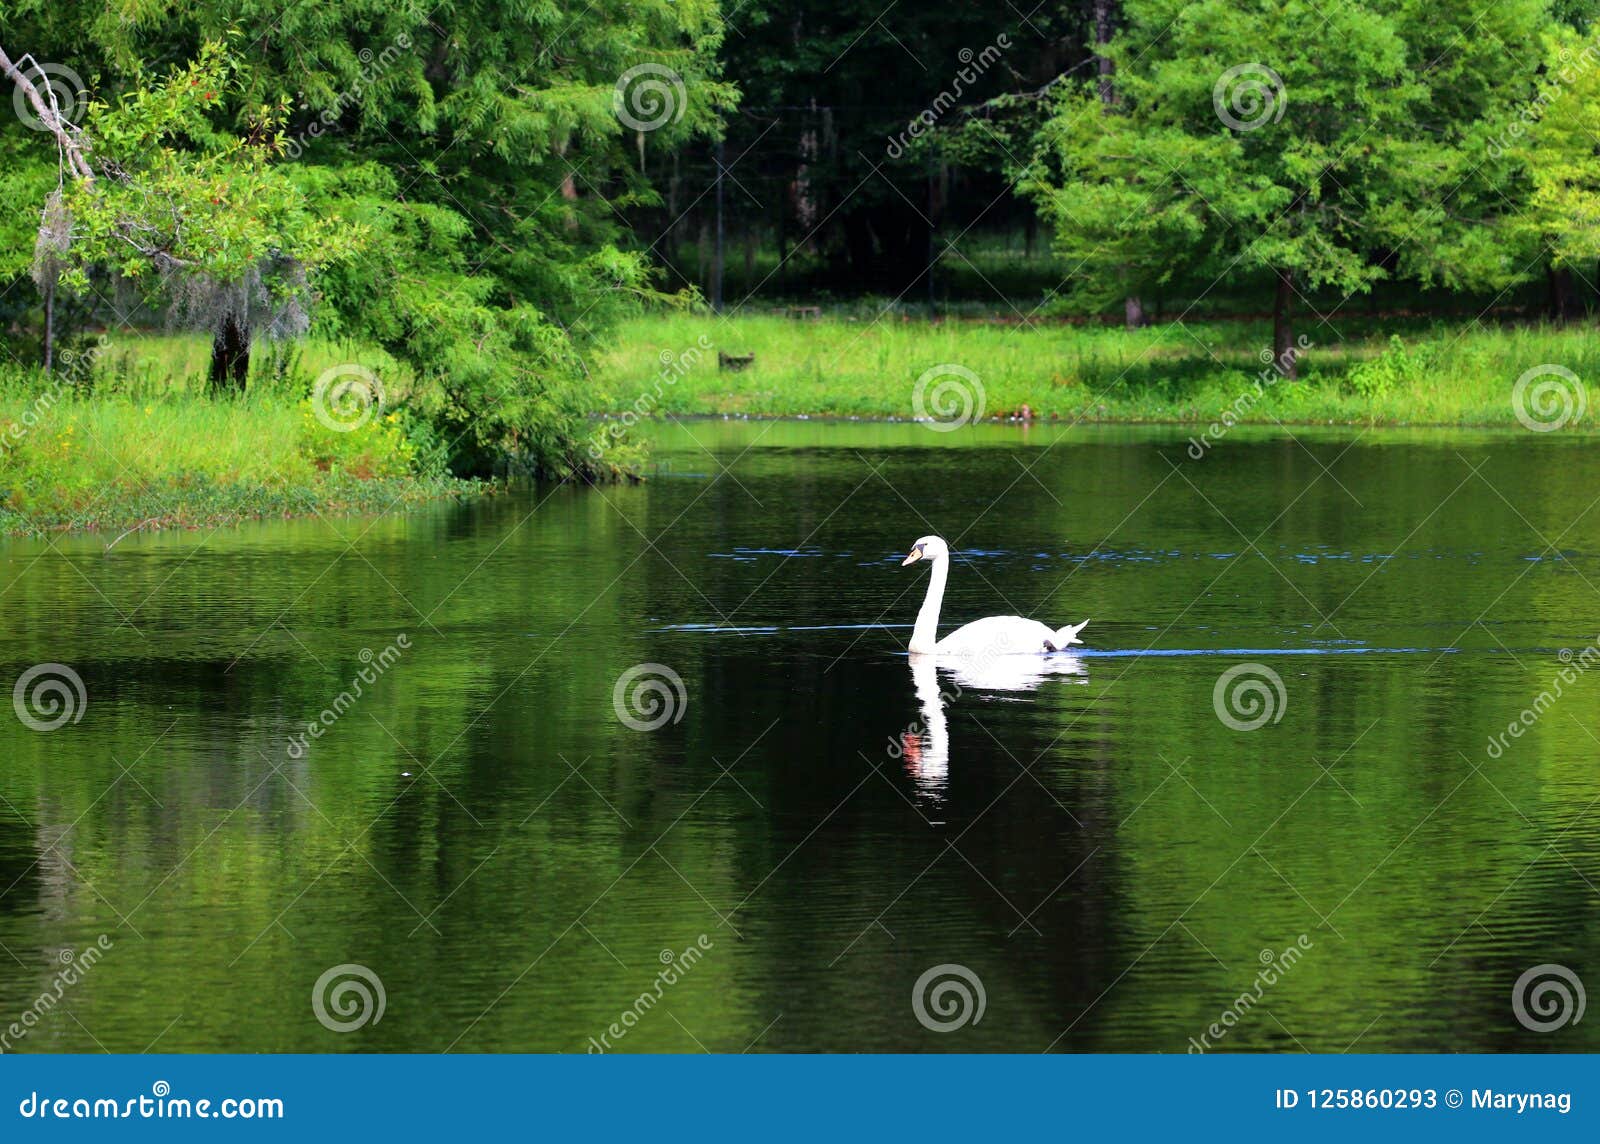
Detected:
[{"left": 595, "top": 315, "right": 1600, "bottom": 429}]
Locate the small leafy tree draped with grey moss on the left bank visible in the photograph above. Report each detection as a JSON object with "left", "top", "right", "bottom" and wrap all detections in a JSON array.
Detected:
[{"left": 24, "top": 43, "right": 360, "bottom": 390}]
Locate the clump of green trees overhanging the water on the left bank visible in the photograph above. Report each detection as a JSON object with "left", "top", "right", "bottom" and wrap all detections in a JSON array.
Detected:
[{"left": 0, "top": 0, "right": 734, "bottom": 475}]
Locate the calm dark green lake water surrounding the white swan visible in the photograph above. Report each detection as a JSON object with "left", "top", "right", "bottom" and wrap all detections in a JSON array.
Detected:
[{"left": 0, "top": 422, "right": 1600, "bottom": 1053}]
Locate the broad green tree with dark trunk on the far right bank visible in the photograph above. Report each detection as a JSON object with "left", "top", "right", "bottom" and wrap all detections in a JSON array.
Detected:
[{"left": 1026, "top": 0, "right": 1547, "bottom": 376}]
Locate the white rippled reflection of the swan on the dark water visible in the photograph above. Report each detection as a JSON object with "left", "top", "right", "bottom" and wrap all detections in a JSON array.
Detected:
[{"left": 901, "top": 653, "right": 1088, "bottom": 802}]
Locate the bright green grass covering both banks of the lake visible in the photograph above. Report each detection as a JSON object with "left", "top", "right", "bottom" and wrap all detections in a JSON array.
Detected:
[{"left": 12, "top": 308, "right": 1600, "bottom": 534}]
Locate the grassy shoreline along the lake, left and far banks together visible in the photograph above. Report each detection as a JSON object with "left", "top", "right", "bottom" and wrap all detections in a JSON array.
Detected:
[{"left": 12, "top": 312, "right": 1600, "bottom": 544}]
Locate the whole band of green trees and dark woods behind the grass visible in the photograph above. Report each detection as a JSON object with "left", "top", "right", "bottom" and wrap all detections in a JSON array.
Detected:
[{"left": 9, "top": 0, "right": 1600, "bottom": 478}]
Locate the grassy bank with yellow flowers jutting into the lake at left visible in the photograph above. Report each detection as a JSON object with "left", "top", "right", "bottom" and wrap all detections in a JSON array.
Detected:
[{"left": 0, "top": 338, "right": 475, "bottom": 534}]
